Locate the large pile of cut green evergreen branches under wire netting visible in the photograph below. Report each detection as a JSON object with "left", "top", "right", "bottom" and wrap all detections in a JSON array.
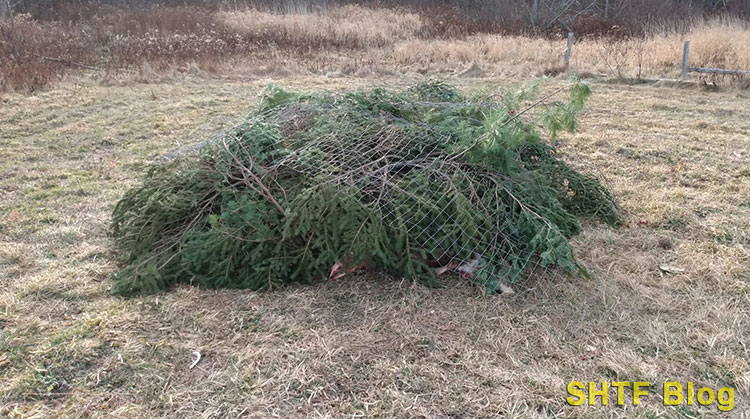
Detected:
[{"left": 112, "top": 82, "right": 620, "bottom": 295}]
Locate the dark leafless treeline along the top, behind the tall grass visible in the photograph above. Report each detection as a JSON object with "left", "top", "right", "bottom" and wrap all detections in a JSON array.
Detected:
[{"left": 10, "top": 0, "right": 750, "bottom": 37}]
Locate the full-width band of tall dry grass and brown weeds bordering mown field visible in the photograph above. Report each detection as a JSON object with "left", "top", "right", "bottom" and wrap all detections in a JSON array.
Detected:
[{"left": 0, "top": 6, "right": 750, "bottom": 91}]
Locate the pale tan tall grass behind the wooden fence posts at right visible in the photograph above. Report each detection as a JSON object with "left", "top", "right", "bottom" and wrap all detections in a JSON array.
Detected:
[{"left": 392, "top": 18, "right": 750, "bottom": 77}]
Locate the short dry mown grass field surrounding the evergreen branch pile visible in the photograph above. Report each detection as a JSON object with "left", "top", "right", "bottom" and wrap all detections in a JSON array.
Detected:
[{"left": 0, "top": 77, "right": 750, "bottom": 417}]
